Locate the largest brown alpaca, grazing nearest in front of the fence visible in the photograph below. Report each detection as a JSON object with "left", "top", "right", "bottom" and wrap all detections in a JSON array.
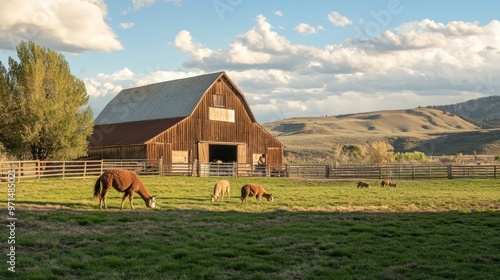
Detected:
[{"left": 94, "top": 169, "right": 156, "bottom": 209}]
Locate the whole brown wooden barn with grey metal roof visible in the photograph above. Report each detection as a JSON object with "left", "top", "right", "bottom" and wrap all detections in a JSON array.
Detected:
[{"left": 88, "top": 72, "right": 284, "bottom": 173}]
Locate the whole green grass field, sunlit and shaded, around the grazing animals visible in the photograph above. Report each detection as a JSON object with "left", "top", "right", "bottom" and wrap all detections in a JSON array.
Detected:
[{"left": 0, "top": 177, "right": 500, "bottom": 279}]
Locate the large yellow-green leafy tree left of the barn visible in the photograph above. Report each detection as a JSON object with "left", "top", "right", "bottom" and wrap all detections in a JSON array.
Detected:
[{"left": 0, "top": 41, "right": 94, "bottom": 160}]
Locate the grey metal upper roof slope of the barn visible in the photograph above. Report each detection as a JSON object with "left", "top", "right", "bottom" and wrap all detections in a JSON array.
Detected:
[{"left": 95, "top": 72, "right": 224, "bottom": 125}]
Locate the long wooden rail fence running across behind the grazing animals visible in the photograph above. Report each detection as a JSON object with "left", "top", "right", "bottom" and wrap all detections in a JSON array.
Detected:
[{"left": 0, "top": 159, "right": 500, "bottom": 181}]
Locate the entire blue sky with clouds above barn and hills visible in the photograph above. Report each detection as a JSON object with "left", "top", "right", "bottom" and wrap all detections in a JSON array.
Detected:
[{"left": 0, "top": 0, "right": 500, "bottom": 123}]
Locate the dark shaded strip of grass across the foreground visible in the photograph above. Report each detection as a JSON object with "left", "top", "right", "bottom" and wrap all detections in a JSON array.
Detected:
[{"left": 10, "top": 207, "right": 500, "bottom": 279}]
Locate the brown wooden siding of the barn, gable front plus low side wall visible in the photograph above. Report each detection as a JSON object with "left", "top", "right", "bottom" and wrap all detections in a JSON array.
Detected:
[{"left": 89, "top": 71, "right": 284, "bottom": 165}]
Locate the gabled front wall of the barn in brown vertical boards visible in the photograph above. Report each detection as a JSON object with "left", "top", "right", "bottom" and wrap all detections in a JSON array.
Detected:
[{"left": 148, "top": 76, "right": 283, "bottom": 164}]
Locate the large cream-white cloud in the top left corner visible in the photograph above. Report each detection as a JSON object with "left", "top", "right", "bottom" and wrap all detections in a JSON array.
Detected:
[{"left": 0, "top": 0, "right": 123, "bottom": 52}]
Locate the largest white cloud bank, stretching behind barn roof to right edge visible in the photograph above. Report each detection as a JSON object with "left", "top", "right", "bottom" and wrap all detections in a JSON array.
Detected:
[{"left": 85, "top": 16, "right": 500, "bottom": 122}]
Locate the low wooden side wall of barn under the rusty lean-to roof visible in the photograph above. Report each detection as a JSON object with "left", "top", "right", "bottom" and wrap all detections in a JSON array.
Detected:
[{"left": 88, "top": 145, "right": 146, "bottom": 159}]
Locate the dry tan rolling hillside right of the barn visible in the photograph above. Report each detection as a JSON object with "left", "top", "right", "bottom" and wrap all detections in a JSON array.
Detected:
[{"left": 263, "top": 108, "right": 500, "bottom": 159}]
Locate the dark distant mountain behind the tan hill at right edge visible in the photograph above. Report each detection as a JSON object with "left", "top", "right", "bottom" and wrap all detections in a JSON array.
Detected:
[{"left": 428, "top": 95, "right": 500, "bottom": 128}]
